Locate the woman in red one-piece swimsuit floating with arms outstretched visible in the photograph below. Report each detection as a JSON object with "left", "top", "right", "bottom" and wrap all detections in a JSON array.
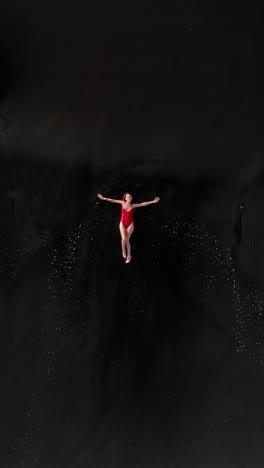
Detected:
[{"left": 97, "top": 193, "right": 160, "bottom": 263}]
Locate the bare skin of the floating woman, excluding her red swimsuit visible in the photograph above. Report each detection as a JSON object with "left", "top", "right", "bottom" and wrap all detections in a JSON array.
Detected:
[{"left": 97, "top": 193, "right": 160, "bottom": 263}]
